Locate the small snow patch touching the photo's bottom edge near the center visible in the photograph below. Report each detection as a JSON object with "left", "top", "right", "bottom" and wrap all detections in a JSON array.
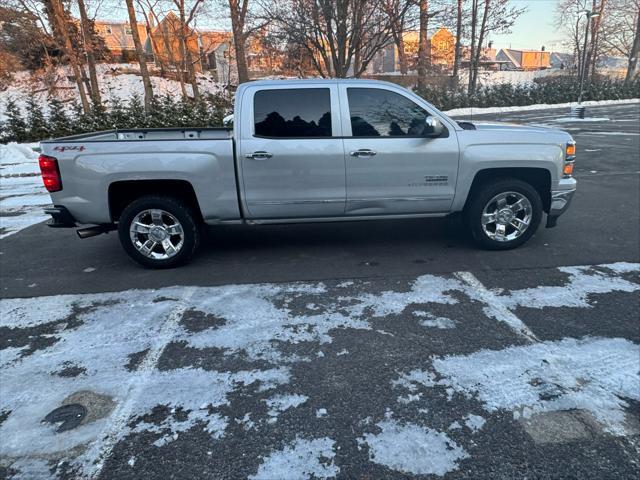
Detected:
[{"left": 249, "top": 437, "right": 340, "bottom": 480}]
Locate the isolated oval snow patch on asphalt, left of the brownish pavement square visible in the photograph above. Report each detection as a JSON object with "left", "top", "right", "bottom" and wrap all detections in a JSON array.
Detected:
[{"left": 359, "top": 418, "right": 469, "bottom": 476}]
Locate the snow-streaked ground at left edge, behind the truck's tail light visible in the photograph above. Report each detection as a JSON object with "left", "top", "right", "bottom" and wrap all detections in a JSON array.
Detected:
[{"left": 0, "top": 143, "right": 51, "bottom": 239}]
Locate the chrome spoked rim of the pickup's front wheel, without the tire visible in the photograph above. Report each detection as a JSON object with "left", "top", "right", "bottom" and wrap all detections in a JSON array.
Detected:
[{"left": 481, "top": 192, "right": 533, "bottom": 242}]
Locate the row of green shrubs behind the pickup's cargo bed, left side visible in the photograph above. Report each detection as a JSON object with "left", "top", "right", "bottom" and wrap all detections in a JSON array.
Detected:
[{"left": 0, "top": 94, "right": 231, "bottom": 143}]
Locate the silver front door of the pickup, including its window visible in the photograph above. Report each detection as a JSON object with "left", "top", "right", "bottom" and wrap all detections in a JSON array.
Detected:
[{"left": 340, "top": 84, "right": 459, "bottom": 215}]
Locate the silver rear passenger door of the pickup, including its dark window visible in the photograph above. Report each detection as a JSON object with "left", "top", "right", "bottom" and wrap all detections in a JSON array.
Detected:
[{"left": 237, "top": 83, "right": 346, "bottom": 219}]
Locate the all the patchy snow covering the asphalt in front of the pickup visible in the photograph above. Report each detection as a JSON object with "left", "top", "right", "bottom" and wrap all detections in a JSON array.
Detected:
[{"left": 0, "top": 263, "right": 640, "bottom": 478}]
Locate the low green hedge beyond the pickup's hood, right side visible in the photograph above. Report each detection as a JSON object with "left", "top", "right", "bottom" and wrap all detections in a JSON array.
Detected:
[{"left": 415, "top": 77, "right": 640, "bottom": 110}]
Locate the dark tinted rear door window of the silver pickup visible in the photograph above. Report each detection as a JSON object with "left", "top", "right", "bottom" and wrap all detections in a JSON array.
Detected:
[{"left": 253, "top": 88, "right": 331, "bottom": 138}]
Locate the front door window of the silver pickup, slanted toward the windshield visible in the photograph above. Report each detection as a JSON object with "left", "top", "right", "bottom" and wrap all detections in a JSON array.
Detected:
[{"left": 347, "top": 88, "right": 429, "bottom": 137}]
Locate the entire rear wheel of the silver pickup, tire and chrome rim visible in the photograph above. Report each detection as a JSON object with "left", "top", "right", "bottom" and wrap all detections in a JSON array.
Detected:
[{"left": 118, "top": 195, "right": 200, "bottom": 268}]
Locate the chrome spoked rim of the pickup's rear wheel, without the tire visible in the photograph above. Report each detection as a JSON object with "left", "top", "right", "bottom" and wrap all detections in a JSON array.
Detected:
[{"left": 129, "top": 208, "right": 184, "bottom": 260}]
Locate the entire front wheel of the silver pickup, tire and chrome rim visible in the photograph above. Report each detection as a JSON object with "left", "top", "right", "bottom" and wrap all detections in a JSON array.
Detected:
[{"left": 465, "top": 179, "right": 542, "bottom": 250}]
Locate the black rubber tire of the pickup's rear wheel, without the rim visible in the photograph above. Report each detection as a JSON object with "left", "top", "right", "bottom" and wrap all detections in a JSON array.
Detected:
[{"left": 118, "top": 195, "right": 200, "bottom": 268}]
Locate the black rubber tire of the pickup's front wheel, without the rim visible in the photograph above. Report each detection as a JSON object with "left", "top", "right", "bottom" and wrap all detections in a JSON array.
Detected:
[{"left": 464, "top": 178, "right": 543, "bottom": 250}]
